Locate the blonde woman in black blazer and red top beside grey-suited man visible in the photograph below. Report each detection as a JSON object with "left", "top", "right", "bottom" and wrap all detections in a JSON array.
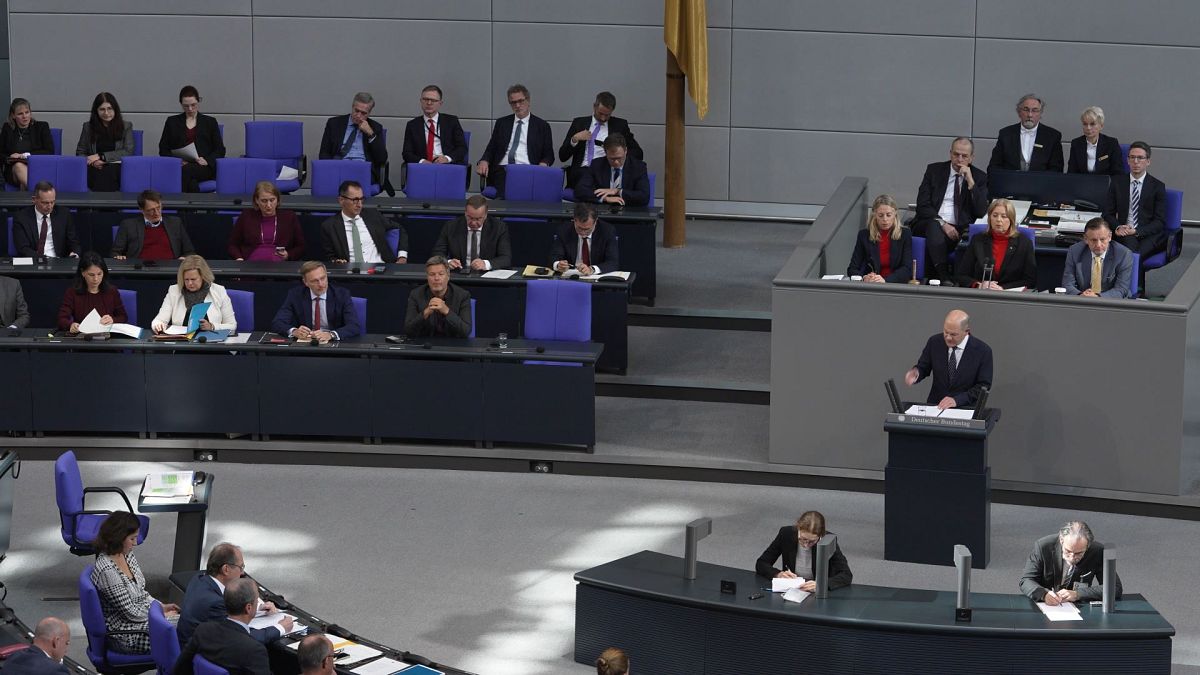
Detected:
[{"left": 956, "top": 199, "right": 1038, "bottom": 291}]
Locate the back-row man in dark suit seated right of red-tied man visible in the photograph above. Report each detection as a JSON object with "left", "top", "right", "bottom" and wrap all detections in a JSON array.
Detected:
[{"left": 475, "top": 84, "right": 554, "bottom": 199}]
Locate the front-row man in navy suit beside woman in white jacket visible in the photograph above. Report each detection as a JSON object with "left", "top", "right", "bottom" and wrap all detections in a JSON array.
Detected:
[{"left": 271, "top": 261, "right": 362, "bottom": 344}]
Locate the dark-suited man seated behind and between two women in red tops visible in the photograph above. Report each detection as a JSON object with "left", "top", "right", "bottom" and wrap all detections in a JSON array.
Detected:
[{"left": 912, "top": 136, "right": 988, "bottom": 281}]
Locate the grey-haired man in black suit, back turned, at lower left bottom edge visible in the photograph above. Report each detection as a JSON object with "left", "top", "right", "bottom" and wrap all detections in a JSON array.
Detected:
[{"left": 174, "top": 571, "right": 271, "bottom": 675}]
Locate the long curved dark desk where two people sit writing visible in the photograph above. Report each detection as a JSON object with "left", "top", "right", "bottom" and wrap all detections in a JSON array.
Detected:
[{"left": 575, "top": 551, "right": 1175, "bottom": 675}]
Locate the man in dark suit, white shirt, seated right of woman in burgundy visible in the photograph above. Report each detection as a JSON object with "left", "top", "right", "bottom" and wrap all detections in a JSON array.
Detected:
[{"left": 320, "top": 180, "right": 408, "bottom": 264}]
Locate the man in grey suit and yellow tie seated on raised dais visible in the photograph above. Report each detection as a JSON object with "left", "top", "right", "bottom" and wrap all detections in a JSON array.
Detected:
[{"left": 1062, "top": 217, "right": 1133, "bottom": 298}]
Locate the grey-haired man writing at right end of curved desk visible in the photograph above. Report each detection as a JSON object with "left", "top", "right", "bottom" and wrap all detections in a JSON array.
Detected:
[{"left": 1020, "top": 520, "right": 1121, "bottom": 605}]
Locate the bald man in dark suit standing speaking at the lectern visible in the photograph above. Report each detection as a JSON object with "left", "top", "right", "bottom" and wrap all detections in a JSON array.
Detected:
[{"left": 904, "top": 310, "right": 991, "bottom": 410}]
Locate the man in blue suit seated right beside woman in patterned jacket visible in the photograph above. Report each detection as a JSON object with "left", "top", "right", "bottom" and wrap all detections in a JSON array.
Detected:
[{"left": 175, "top": 542, "right": 293, "bottom": 646}]
